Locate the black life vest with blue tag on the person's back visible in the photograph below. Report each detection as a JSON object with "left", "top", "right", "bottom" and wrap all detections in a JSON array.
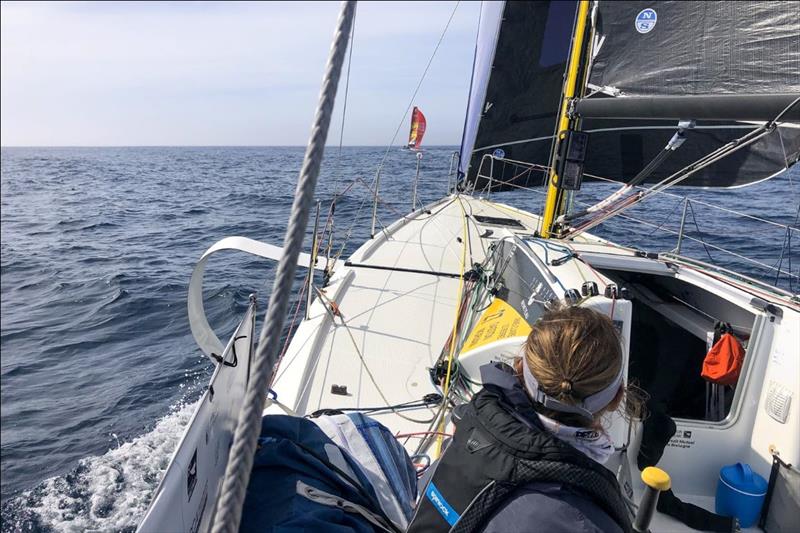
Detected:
[{"left": 408, "top": 364, "right": 632, "bottom": 533}]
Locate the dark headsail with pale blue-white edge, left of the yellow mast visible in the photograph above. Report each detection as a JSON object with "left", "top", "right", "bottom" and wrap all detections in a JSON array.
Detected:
[{"left": 459, "top": 1, "right": 577, "bottom": 187}]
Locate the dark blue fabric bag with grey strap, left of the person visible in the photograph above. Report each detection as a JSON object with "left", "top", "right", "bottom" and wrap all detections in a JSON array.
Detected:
[{"left": 239, "top": 415, "right": 406, "bottom": 533}]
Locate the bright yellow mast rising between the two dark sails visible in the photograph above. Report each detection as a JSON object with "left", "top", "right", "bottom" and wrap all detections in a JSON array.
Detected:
[{"left": 541, "top": 0, "right": 589, "bottom": 238}]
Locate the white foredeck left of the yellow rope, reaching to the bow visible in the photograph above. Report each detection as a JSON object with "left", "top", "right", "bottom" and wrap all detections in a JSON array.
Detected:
[{"left": 269, "top": 196, "right": 538, "bottom": 433}]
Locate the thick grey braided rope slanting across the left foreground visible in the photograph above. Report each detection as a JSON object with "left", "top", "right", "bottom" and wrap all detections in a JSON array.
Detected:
[{"left": 212, "top": 0, "right": 356, "bottom": 533}]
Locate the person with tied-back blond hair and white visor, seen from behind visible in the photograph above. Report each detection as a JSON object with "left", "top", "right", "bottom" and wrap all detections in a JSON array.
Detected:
[{"left": 408, "top": 307, "right": 637, "bottom": 533}]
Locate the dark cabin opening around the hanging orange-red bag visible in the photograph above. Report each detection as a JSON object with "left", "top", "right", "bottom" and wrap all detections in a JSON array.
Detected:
[{"left": 603, "top": 270, "right": 755, "bottom": 423}]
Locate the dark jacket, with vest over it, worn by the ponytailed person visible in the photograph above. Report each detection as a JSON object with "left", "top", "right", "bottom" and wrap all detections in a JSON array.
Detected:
[{"left": 409, "top": 363, "right": 631, "bottom": 533}]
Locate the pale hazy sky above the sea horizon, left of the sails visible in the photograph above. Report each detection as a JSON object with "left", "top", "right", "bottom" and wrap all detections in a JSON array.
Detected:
[{"left": 0, "top": 2, "right": 480, "bottom": 146}]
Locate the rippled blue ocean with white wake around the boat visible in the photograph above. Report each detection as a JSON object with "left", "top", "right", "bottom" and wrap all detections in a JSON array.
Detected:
[{"left": 0, "top": 147, "right": 800, "bottom": 532}]
